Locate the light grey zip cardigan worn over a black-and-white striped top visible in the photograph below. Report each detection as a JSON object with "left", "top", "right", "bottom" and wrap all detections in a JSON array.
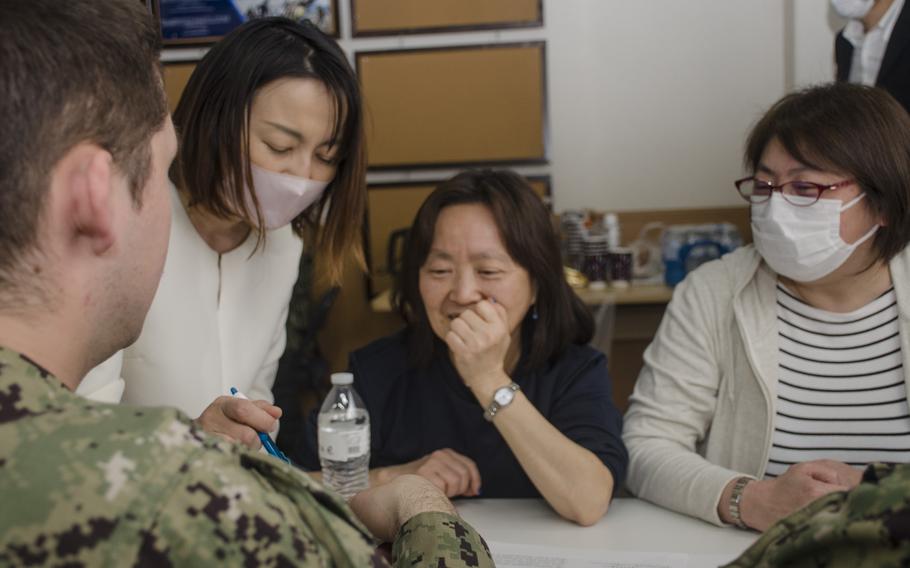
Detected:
[{"left": 623, "top": 246, "right": 910, "bottom": 525}]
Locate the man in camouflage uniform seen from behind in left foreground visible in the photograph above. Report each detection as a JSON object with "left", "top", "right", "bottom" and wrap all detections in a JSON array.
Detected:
[{"left": 0, "top": 0, "right": 492, "bottom": 566}]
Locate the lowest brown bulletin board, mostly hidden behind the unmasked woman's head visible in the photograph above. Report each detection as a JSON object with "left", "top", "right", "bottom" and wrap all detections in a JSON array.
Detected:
[{"left": 363, "top": 176, "right": 550, "bottom": 297}]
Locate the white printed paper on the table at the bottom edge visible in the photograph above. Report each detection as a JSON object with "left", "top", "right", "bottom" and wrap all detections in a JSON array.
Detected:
[{"left": 488, "top": 542, "right": 688, "bottom": 568}]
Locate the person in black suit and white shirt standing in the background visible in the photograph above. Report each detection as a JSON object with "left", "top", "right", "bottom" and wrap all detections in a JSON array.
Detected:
[{"left": 833, "top": 0, "right": 910, "bottom": 110}]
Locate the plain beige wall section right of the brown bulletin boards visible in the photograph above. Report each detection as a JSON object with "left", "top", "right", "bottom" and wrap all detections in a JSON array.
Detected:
[{"left": 545, "top": 0, "right": 792, "bottom": 210}]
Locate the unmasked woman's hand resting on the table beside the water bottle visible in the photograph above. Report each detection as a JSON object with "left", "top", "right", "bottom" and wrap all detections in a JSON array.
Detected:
[{"left": 370, "top": 448, "right": 480, "bottom": 497}]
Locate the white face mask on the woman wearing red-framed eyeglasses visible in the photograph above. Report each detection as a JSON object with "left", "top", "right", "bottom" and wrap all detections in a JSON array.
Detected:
[{"left": 752, "top": 193, "right": 878, "bottom": 282}]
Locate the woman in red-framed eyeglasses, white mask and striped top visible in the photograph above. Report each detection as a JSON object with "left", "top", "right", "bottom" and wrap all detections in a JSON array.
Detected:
[{"left": 623, "top": 84, "right": 910, "bottom": 531}]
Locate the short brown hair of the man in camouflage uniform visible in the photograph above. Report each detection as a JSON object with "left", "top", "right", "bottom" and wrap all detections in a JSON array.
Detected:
[{"left": 0, "top": 0, "right": 167, "bottom": 303}]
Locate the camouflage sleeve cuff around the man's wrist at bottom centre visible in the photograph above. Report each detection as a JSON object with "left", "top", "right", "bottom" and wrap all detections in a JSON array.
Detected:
[{"left": 392, "top": 513, "right": 494, "bottom": 568}]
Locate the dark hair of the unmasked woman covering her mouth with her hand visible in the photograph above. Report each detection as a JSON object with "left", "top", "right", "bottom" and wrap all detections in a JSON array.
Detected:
[{"left": 393, "top": 170, "right": 594, "bottom": 370}]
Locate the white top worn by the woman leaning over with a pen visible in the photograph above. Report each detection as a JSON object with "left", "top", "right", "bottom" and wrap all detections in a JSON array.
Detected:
[{"left": 76, "top": 187, "right": 303, "bottom": 417}]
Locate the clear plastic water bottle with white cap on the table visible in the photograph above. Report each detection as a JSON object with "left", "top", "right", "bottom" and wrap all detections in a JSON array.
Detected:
[{"left": 318, "top": 373, "right": 370, "bottom": 499}]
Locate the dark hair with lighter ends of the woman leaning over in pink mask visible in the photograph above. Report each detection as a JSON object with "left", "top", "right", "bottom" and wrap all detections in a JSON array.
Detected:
[{"left": 171, "top": 18, "right": 366, "bottom": 283}]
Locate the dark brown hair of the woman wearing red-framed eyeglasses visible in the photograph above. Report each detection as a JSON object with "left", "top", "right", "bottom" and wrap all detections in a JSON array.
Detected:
[{"left": 744, "top": 83, "right": 910, "bottom": 262}]
